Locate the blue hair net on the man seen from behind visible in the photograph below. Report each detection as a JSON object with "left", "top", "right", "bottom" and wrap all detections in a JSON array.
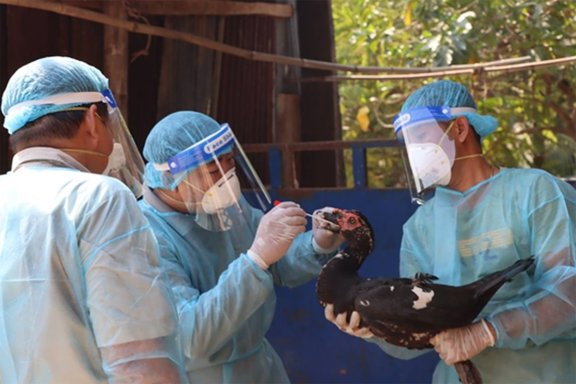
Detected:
[{"left": 2, "top": 56, "right": 108, "bottom": 134}]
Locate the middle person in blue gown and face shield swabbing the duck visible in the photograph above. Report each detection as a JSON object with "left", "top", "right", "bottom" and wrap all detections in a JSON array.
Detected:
[{"left": 140, "top": 111, "right": 343, "bottom": 383}]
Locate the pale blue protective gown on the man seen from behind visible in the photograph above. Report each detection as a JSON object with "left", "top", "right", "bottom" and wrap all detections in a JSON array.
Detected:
[{"left": 0, "top": 148, "right": 185, "bottom": 384}]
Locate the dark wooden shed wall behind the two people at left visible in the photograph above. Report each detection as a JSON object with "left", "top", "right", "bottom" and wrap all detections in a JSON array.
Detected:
[{"left": 0, "top": 0, "right": 344, "bottom": 187}]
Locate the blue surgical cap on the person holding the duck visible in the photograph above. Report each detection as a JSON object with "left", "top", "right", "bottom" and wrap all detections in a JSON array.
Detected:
[{"left": 400, "top": 80, "right": 498, "bottom": 138}]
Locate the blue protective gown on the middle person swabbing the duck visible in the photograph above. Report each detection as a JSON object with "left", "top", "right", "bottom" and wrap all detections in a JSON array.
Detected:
[{"left": 140, "top": 188, "right": 332, "bottom": 383}]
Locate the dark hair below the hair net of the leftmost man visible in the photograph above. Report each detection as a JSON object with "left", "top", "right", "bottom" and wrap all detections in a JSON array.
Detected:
[{"left": 9, "top": 103, "right": 108, "bottom": 153}]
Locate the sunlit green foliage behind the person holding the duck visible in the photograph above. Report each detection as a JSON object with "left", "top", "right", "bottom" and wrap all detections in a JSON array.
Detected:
[{"left": 332, "top": 0, "right": 576, "bottom": 187}]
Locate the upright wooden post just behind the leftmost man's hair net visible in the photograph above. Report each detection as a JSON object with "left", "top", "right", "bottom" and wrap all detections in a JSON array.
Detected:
[{"left": 103, "top": 1, "right": 130, "bottom": 119}]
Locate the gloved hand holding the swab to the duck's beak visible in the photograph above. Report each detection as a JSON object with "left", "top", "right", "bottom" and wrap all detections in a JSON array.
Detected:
[{"left": 248, "top": 201, "right": 306, "bottom": 269}]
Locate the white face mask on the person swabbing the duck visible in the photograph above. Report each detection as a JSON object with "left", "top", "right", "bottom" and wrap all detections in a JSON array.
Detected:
[{"left": 186, "top": 168, "right": 240, "bottom": 214}]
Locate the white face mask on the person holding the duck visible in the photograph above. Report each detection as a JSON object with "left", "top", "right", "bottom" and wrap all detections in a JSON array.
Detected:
[{"left": 406, "top": 143, "right": 452, "bottom": 190}]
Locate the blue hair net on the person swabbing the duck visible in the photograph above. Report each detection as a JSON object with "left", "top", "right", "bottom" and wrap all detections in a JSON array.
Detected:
[{"left": 143, "top": 111, "right": 220, "bottom": 189}]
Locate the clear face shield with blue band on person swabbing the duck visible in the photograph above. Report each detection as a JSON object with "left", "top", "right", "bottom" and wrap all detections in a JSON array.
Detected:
[{"left": 154, "top": 124, "right": 271, "bottom": 231}]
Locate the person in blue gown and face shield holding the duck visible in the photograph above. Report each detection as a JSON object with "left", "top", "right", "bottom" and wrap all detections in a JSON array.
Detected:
[{"left": 327, "top": 81, "right": 576, "bottom": 383}]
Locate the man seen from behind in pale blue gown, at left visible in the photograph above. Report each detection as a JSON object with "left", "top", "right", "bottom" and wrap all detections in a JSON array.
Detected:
[{"left": 0, "top": 57, "right": 187, "bottom": 383}]
